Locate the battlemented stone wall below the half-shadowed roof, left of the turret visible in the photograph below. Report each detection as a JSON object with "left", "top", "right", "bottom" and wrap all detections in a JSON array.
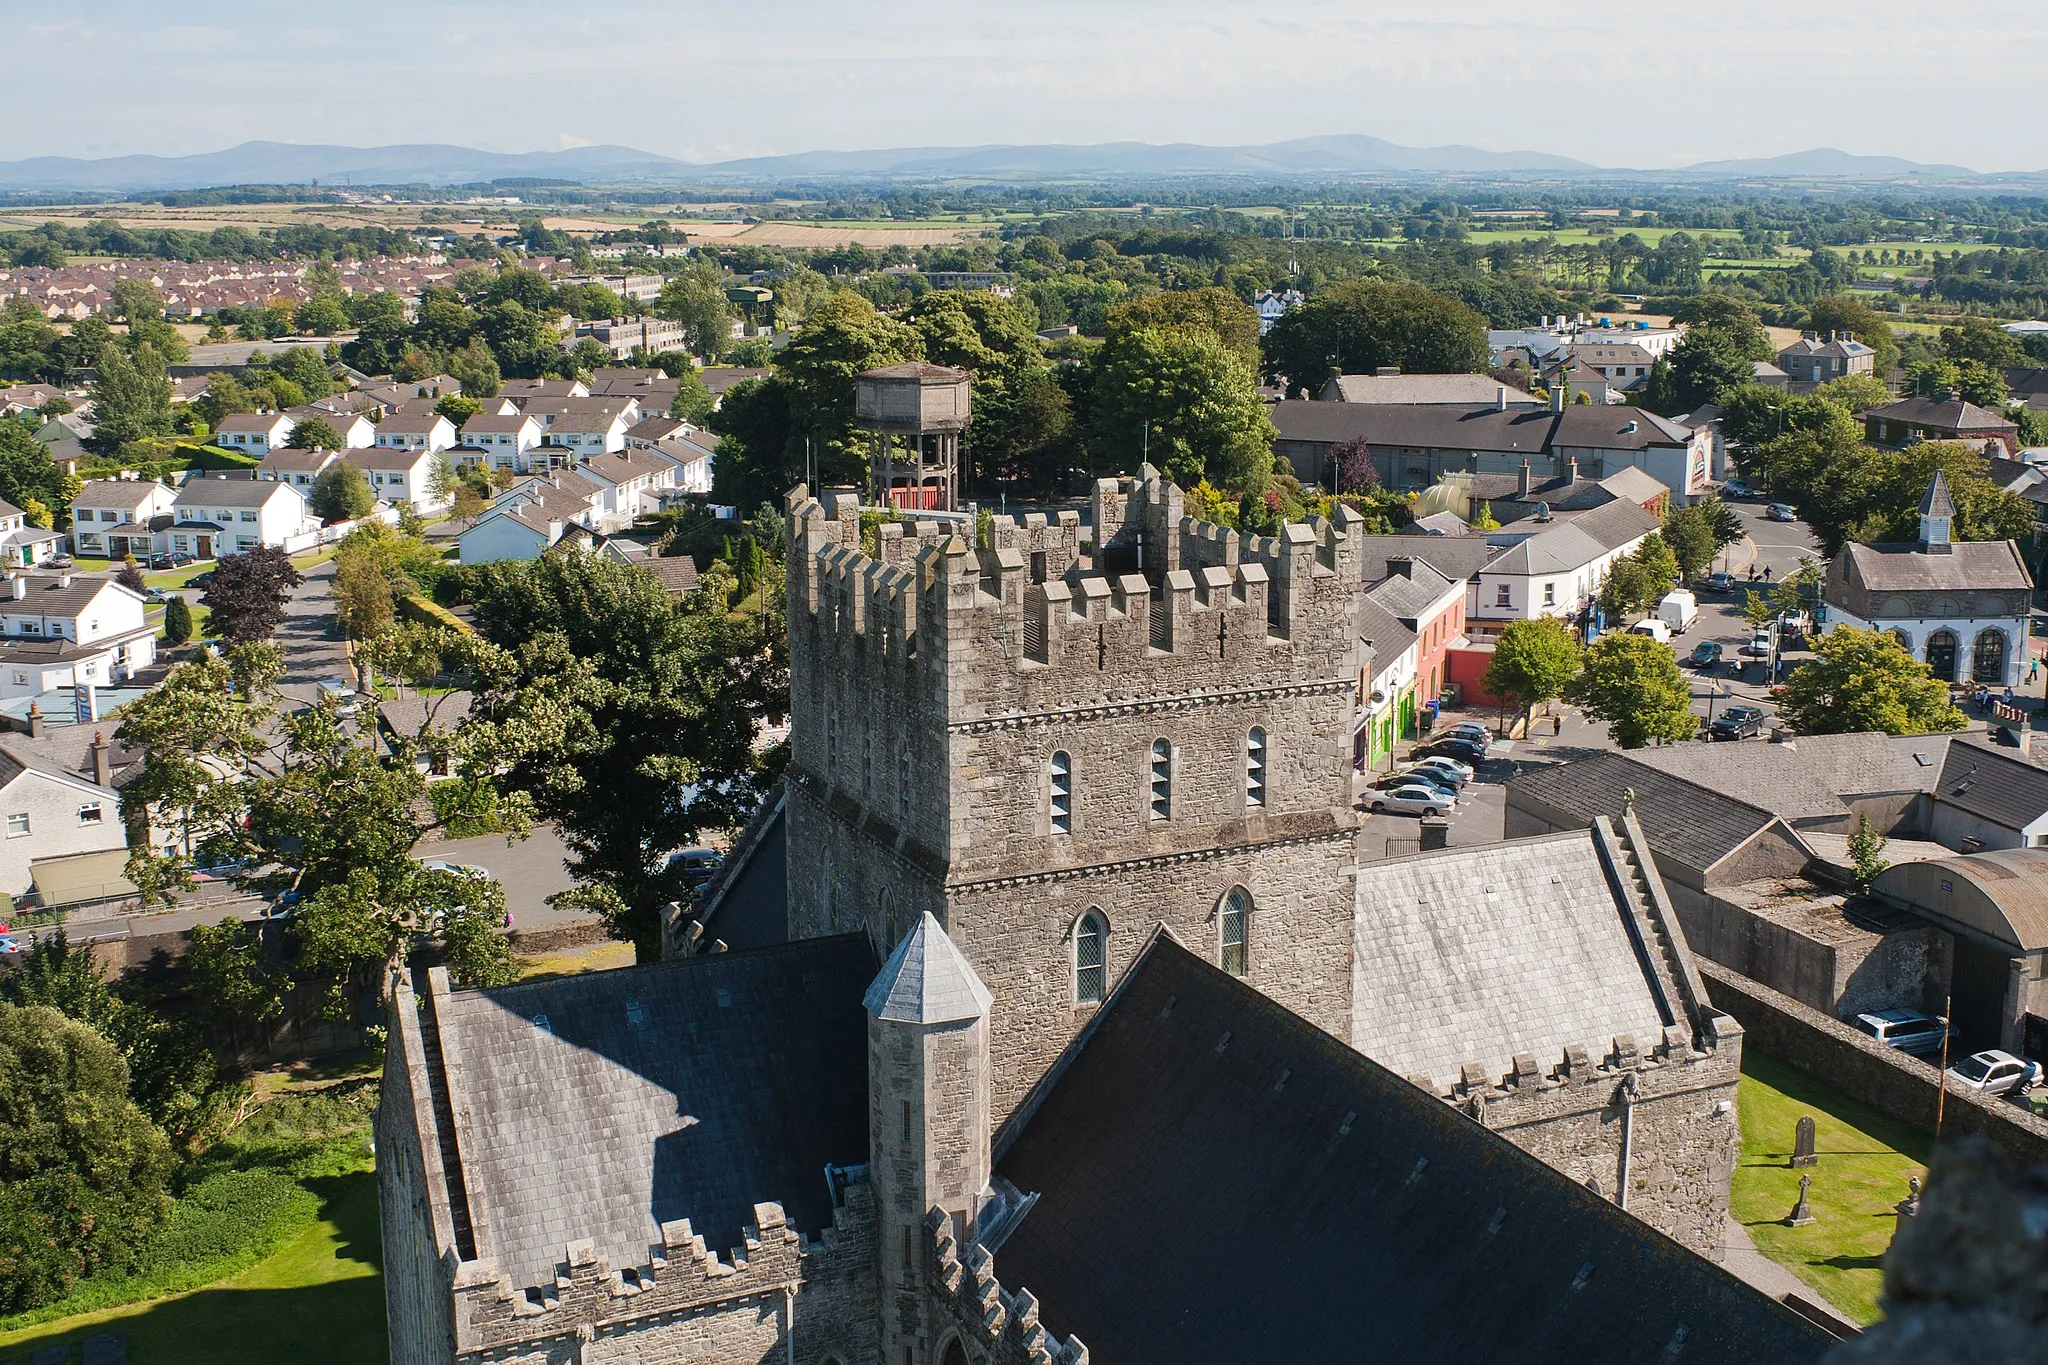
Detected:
[{"left": 455, "top": 1183, "right": 881, "bottom": 1365}]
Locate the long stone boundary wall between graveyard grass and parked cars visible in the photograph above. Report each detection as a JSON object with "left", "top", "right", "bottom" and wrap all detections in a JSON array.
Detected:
[{"left": 1700, "top": 962, "right": 2048, "bottom": 1164}]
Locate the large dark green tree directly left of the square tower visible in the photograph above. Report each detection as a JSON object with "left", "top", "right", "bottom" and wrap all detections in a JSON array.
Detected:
[{"left": 471, "top": 553, "right": 788, "bottom": 962}]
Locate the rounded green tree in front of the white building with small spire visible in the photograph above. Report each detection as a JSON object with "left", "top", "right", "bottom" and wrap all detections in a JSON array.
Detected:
[{"left": 1778, "top": 626, "right": 1964, "bottom": 735}]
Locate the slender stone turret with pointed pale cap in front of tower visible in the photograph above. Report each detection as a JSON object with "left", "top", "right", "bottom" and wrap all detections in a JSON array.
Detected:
[{"left": 862, "top": 913, "right": 991, "bottom": 1365}]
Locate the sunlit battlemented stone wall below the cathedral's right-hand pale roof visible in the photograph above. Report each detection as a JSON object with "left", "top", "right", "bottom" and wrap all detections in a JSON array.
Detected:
[{"left": 1454, "top": 1015, "right": 1743, "bottom": 1261}]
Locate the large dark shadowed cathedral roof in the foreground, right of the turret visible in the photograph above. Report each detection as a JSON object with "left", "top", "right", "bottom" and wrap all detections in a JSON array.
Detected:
[{"left": 995, "top": 937, "right": 1829, "bottom": 1365}]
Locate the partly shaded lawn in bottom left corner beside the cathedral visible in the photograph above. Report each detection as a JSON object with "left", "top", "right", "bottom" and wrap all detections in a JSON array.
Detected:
[{"left": 0, "top": 1158, "right": 385, "bottom": 1365}]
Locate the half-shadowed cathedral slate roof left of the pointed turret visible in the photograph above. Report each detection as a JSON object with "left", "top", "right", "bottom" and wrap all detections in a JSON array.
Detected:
[{"left": 436, "top": 935, "right": 874, "bottom": 1287}]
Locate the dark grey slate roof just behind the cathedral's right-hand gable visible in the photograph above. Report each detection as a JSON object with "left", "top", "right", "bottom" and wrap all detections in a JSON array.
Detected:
[{"left": 1507, "top": 745, "right": 1776, "bottom": 872}]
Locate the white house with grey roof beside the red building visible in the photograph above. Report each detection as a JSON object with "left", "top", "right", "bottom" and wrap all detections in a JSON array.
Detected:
[{"left": 1464, "top": 497, "right": 1661, "bottom": 639}]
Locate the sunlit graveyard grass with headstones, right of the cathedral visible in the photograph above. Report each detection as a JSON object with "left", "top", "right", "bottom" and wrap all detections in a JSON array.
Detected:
[{"left": 1731, "top": 1050, "right": 1931, "bottom": 1324}]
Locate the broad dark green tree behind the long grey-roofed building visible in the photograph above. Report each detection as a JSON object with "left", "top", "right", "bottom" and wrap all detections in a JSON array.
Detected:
[{"left": 1262, "top": 280, "right": 1489, "bottom": 397}]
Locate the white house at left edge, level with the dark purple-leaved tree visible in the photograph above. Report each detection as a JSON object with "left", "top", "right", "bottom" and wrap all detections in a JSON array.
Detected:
[{"left": 0, "top": 573, "right": 156, "bottom": 698}]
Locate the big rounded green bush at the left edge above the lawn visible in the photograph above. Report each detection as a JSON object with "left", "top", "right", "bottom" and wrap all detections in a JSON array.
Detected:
[{"left": 0, "top": 1005, "right": 172, "bottom": 1314}]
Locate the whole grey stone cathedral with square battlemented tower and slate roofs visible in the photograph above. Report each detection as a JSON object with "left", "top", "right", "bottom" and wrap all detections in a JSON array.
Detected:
[{"left": 379, "top": 469, "right": 1827, "bottom": 1365}]
